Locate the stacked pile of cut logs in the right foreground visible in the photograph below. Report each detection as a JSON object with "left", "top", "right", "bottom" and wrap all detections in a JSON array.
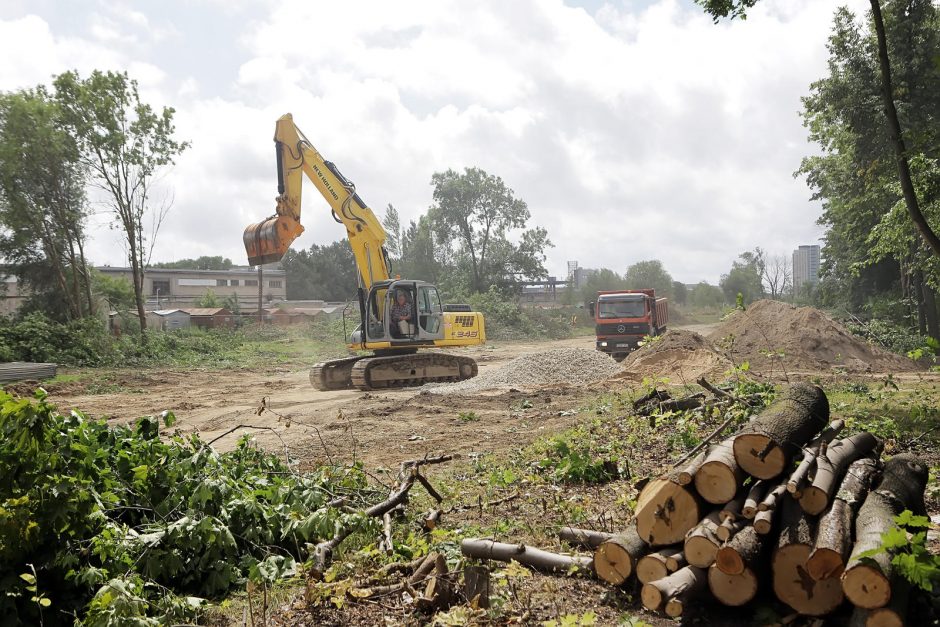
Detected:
[{"left": 461, "top": 384, "right": 928, "bottom": 626}]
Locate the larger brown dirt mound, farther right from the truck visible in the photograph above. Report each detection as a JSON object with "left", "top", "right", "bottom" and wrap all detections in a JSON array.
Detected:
[{"left": 708, "top": 300, "right": 919, "bottom": 375}]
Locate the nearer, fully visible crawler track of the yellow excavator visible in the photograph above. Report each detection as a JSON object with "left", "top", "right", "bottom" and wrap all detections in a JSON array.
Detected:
[{"left": 350, "top": 352, "right": 478, "bottom": 390}]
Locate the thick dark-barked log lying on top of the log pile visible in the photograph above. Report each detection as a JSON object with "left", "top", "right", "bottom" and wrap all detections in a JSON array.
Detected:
[{"left": 734, "top": 384, "right": 829, "bottom": 479}]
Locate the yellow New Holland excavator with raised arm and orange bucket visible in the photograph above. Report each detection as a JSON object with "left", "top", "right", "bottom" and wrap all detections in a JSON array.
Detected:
[{"left": 244, "top": 113, "right": 486, "bottom": 390}]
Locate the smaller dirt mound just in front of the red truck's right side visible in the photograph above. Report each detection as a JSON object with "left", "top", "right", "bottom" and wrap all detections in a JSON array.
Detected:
[{"left": 618, "top": 329, "right": 732, "bottom": 383}]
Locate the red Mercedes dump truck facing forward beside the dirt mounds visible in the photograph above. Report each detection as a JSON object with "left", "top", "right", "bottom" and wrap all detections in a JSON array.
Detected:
[{"left": 590, "top": 289, "right": 669, "bottom": 359}]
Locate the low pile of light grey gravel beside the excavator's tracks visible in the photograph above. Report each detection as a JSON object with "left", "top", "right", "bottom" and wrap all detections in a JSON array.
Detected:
[{"left": 425, "top": 348, "right": 621, "bottom": 394}]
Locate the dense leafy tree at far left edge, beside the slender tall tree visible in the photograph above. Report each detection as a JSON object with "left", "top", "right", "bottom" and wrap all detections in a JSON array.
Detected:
[{"left": 0, "top": 87, "right": 95, "bottom": 319}]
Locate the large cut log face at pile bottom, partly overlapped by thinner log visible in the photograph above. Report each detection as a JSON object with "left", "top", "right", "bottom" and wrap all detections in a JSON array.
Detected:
[{"left": 771, "top": 544, "right": 844, "bottom": 616}]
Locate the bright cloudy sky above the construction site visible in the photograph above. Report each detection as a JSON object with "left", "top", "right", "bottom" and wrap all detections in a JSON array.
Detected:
[{"left": 0, "top": 0, "right": 868, "bottom": 283}]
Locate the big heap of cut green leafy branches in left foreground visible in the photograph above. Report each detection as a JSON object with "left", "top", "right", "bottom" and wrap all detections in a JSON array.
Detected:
[{"left": 0, "top": 392, "right": 366, "bottom": 625}]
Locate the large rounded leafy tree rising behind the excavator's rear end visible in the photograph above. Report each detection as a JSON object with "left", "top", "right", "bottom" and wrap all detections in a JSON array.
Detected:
[{"left": 428, "top": 168, "right": 552, "bottom": 293}]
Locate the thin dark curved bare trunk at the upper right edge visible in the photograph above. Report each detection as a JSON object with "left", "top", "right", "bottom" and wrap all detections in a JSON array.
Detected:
[{"left": 871, "top": 0, "right": 940, "bottom": 257}]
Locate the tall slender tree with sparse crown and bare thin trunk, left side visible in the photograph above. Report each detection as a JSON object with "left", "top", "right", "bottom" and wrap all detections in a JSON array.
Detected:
[{"left": 53, "top": 71, "right": 188, "bottom": 341}]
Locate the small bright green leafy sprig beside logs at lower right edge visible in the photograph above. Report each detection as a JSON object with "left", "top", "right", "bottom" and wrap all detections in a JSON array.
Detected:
[{"left": 859, "top": 510, "right": 940, "bottom": 592}]
